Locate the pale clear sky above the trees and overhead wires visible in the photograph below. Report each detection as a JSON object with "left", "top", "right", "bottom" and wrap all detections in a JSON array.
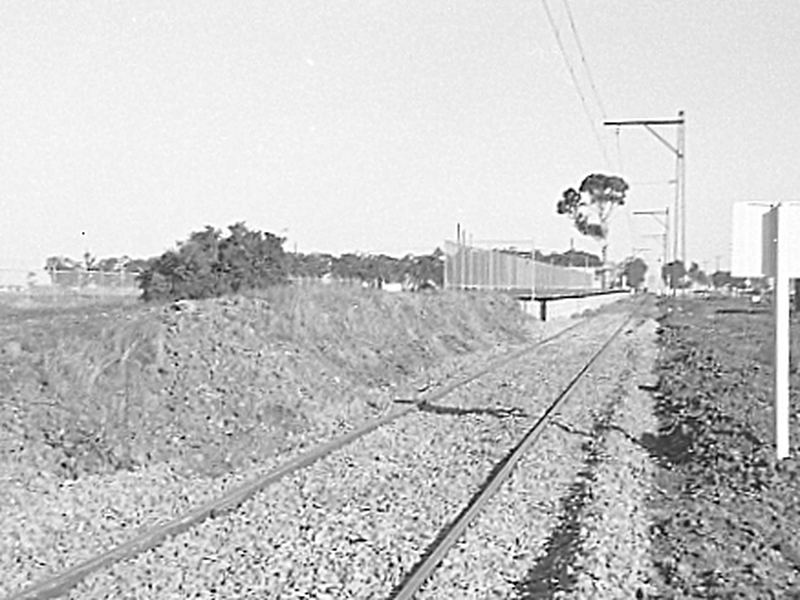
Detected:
[{"left": 0, "top": 0, "right": 800, "bottom": 270}]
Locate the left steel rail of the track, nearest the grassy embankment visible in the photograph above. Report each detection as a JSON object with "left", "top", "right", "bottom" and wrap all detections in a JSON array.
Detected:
[{"left": 6, "top": 318, "right": 590, "bottom": 600}]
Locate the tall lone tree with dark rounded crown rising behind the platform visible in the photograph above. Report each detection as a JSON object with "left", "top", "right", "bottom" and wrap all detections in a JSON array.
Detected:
[{"left": 556, "top": 173, "right": 628, "bottom": 287}]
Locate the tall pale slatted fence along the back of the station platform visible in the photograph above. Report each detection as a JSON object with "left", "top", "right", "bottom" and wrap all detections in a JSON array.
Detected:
[{"left": 444, "top": 241, "right": 597, "bottom": 296}]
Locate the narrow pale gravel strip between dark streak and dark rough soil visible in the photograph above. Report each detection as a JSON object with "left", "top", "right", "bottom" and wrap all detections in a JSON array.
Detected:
[{"left": 575, "top": 321, "right": 659, "bottom": 599}]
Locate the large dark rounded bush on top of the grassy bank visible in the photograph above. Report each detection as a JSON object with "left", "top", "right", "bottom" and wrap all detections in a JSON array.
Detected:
[{"left": 137, "top": 223, "right": 287, "bottom": 301}]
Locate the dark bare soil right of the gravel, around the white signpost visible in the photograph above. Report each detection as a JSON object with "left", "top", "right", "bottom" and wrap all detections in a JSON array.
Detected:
[{"left": 642, "top": 300, "right": 800, "bottom": 598}]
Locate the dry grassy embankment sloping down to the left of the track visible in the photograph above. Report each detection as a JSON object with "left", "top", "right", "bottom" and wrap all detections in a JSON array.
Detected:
[{"left": 0, "top": 286, "right": 527, "bottom": 477}]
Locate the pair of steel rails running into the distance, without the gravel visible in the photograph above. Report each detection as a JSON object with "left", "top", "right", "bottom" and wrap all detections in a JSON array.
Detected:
[{"left": 10, "top": 308, "right": 644, "bottom": 599}]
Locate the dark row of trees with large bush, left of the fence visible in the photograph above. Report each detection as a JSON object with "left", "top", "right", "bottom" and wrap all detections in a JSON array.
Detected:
[{"left": 45, "top": 222, "right": 444, "bottom": 301}]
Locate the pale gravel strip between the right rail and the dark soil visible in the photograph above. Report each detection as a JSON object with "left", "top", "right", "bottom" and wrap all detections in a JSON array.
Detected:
[{"left": 419, "top": 312, "right": 656, "bottom": 599}]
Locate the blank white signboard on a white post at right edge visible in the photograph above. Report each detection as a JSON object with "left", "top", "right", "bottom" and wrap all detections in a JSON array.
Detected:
[{"left": 731, "top": 202, "right": 800, "bottom": 459}]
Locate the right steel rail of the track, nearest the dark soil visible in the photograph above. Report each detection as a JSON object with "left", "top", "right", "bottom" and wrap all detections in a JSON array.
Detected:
[{"left": 390, "top": 314, "right": 635, "bottom": 600}]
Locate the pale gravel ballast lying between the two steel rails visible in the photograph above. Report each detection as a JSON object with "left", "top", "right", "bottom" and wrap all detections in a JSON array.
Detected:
[{"left": 6, "top": 308, "right": 648, "bottom": 598}]
